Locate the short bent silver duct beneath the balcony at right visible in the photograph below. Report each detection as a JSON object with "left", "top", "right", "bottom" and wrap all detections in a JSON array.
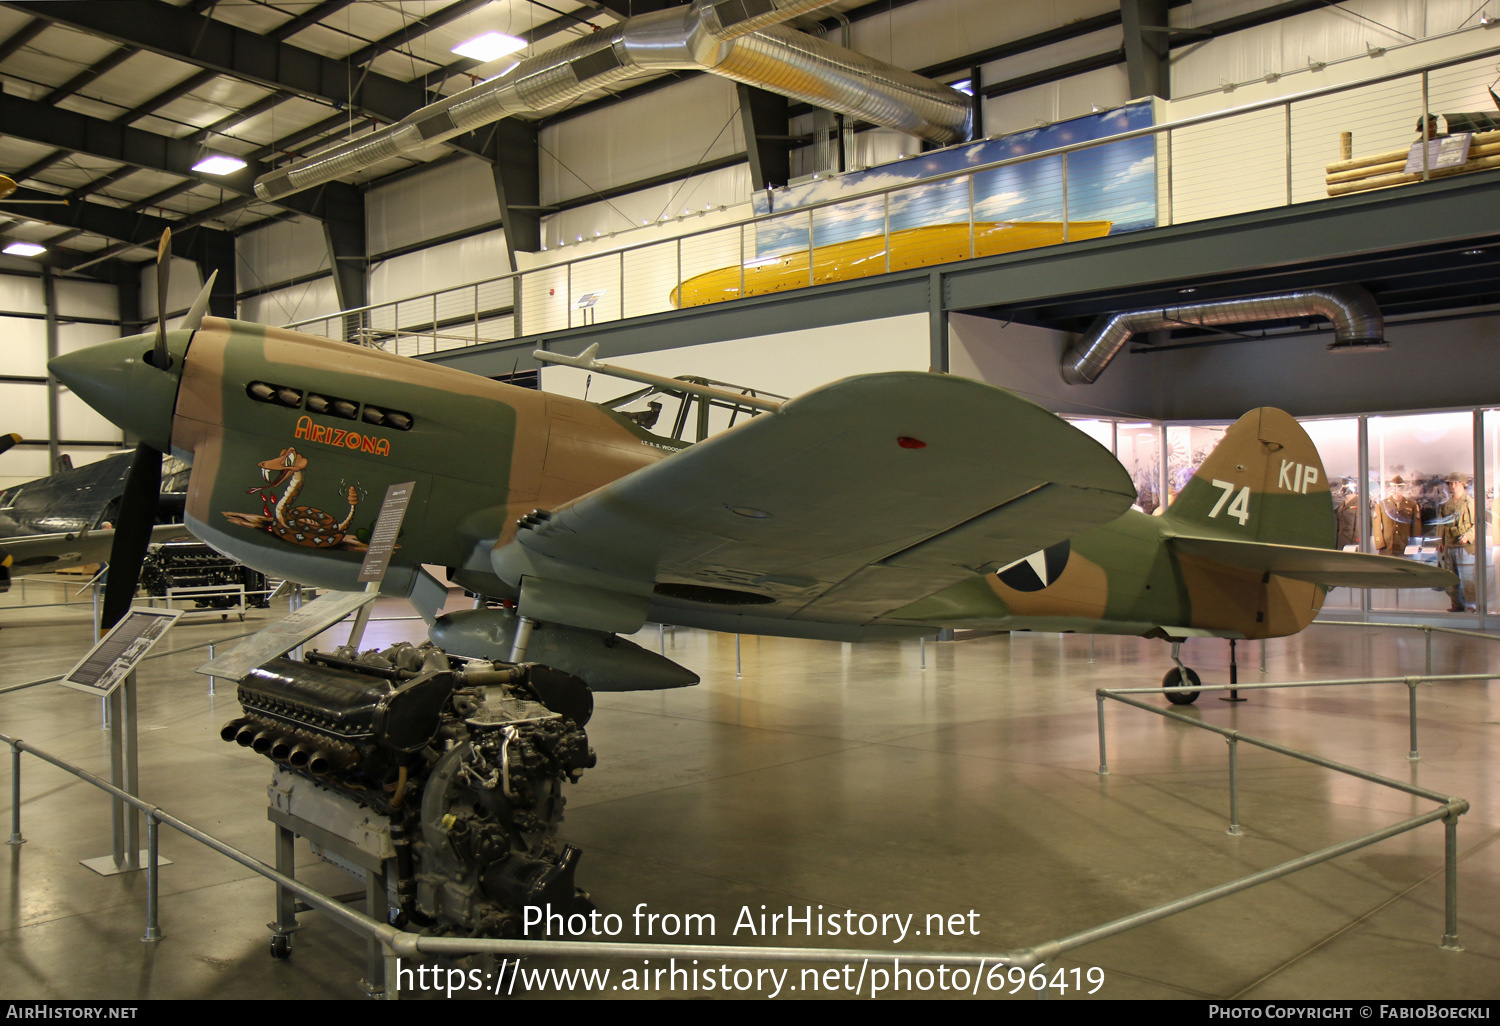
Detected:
[{"left": 1062, "top": 285, "right": 1385, "bottom": 384}]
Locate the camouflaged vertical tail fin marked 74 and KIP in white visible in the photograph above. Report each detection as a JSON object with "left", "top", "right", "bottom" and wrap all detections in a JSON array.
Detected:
[{"left": 1164, "top": 407, "right": 1337, "bottom": 549}]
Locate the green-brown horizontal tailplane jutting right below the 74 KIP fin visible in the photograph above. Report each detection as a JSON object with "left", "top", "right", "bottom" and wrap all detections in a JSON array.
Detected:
[{"left": 1169, "top": 536, "right": 1458, "bottom": 588}]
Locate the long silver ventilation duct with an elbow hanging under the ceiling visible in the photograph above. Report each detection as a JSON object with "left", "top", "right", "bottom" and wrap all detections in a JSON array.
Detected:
[{"left": 255, "top": 0, "right": 971, "bottom": 200}]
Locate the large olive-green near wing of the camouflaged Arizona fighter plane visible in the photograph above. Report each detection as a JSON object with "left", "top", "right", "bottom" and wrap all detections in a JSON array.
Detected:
[{"left": 495, "top": 372, "right": 1136, "bottom": 629}]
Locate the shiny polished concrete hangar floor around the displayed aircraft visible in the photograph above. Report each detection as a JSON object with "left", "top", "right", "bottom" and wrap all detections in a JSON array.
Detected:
[{"left": 0, "top": 585, "right": 1500, "bottom": 999}]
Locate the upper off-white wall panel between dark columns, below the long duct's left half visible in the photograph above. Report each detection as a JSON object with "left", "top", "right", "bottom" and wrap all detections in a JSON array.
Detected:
[{"left": 365, "top": 158, "right": 501, "bottom": 254}]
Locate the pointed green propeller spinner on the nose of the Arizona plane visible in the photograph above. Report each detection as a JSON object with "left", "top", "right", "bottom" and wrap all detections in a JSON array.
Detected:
[{"left": 47, "top": 332, "right": 192, "bottom": 453}]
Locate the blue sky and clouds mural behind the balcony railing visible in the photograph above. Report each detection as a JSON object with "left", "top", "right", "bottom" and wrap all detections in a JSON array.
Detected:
[{"left": 755, "top": 102, "right": 1157, "bottom": 257}]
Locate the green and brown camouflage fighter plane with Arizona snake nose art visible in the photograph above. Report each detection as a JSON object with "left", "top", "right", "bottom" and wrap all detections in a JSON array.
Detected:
[{"left": 50, "top": 318, "right": 1451, "bottom": 690}]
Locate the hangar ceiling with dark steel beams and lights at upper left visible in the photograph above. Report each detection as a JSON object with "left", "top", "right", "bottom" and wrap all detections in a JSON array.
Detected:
[{"left": 0, "top": 0, "right": 902, "bottom": 279}]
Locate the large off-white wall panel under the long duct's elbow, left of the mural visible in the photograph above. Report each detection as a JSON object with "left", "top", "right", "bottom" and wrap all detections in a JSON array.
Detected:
[{"left": 542, "top": 75, "right": 746, "bottom": 208}]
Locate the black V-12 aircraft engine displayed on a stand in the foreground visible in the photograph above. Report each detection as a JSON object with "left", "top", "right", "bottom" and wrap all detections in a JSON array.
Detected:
[{"left": 221, "top": 642, "right": 596, "bottom": 938}]
